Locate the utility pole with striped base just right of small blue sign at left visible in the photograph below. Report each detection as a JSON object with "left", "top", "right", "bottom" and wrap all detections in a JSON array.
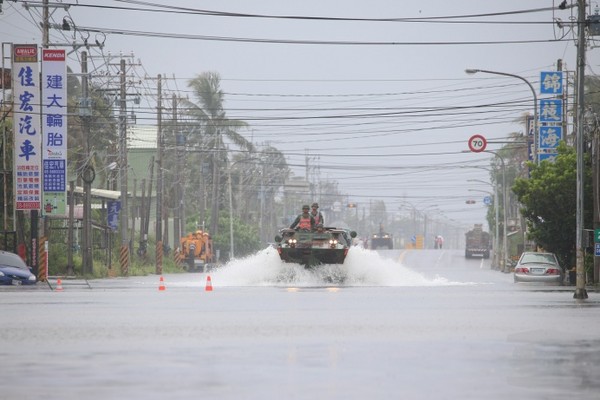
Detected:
[{"left": 119, "top": 59, "right": 129, "bottom": 276}]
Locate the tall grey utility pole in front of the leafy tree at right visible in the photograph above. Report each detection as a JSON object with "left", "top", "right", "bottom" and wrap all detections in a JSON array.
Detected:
[{"left": 573, "top": 0, "right": 588, "bottom": 299}]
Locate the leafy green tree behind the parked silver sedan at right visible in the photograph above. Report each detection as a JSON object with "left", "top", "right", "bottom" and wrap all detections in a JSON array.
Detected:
[{"left": 512, "top": 142, "right": 593, "bottom": 268}]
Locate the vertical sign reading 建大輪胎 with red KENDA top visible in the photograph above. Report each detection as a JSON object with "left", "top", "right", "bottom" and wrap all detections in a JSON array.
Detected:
[{"left": 41, "top": 49, "right": 67, "bottom": 215}]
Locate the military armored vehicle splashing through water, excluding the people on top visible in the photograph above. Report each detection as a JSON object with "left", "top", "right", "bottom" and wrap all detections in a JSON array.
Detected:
[{"left": 275, "top": 227, "right": 356, "bottom": 268}]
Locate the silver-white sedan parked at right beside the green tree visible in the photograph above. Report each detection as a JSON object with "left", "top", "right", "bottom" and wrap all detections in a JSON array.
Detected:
[{"left": 514, "top": 251, "right": 563, "bottom": 284}]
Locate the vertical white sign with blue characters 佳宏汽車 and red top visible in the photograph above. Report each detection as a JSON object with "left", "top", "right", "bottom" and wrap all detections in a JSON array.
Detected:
[{"left": 12, "top": 45, "right": 42, "bottom": 210}]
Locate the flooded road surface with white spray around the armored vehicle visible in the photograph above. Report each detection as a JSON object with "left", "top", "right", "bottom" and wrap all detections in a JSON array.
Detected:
[{"left": 0, "top": 248, "right": 600, "bottom": 400}]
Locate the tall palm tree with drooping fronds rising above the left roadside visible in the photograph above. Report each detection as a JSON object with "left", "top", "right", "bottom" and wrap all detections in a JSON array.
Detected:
[{"left": 181, "top": 72, "right": 254, "bottom": 235}]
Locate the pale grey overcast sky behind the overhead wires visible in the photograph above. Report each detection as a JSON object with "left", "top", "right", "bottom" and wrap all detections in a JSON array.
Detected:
[{"left": 0, "top": 0, "right": 599, "bottom": 231}]
